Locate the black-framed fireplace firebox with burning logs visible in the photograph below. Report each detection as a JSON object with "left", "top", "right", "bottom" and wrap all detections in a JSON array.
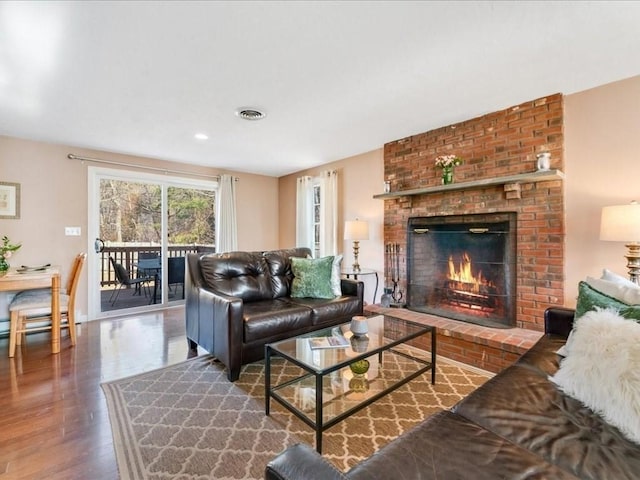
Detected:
[{"left": 407, "top": 212, "right": 516, "bottom": 328}]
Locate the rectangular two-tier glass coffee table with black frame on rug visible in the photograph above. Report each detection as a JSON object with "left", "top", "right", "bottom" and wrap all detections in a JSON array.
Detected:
[{"left": 265, "top": 315, "right": 436, "bottom": 453}]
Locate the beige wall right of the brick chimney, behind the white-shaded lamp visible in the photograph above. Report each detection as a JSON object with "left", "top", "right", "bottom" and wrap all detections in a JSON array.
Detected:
[{"left": 565, "top": 76, "right": 640, "bottom": 306}]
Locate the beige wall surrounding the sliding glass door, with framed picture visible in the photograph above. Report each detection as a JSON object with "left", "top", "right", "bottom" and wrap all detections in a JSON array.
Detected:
[{"left": 0, "top": 136, "right": 278, "bottom": 322}]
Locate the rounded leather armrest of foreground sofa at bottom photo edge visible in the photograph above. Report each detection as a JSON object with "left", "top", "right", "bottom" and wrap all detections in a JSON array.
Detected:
[{"left": 264, "top": 443, "right": 347, "bottom": 480}]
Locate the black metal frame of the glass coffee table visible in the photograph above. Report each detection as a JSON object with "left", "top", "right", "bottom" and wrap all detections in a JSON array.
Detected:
[{"left": 265, "top": 316, "right": 436, "bottom": 453}]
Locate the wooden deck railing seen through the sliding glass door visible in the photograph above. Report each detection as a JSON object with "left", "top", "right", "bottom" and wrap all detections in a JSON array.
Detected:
[{"left": 100, "top": 245, "right": 216, "bottom": 287}]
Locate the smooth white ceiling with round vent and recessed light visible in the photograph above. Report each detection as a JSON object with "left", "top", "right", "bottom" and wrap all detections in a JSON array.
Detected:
[{"left": 0, "top": 1, "right": 640, "bottom": 176}]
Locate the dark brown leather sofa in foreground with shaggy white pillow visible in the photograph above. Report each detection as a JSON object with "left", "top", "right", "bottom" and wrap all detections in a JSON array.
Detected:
[{"left": 265, "top": 308, "right": 640, "bottom": 480}]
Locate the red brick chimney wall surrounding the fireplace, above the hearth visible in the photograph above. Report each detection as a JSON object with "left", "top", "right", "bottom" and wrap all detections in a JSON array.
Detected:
[{"left": 384, "top": 94, "right": 564, "bottom": 330}]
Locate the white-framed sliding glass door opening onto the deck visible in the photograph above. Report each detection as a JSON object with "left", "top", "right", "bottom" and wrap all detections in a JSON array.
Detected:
[{"left": 89, "top": 168, "right": 217, "bottom": 318}]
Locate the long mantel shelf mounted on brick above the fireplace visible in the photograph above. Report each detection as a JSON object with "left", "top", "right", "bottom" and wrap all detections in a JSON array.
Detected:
[{"left": 373, "top": 170, "right": 564, "bottom": 200}]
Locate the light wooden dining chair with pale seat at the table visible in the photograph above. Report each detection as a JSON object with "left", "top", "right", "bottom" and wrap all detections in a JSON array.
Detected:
[{"left": 9, "top": 253, "right": 87, "bottom": 357}]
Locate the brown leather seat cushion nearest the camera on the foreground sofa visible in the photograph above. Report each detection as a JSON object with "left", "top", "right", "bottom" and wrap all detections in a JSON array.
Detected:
[{"left": 347, "top": 411, "right": 576, "bottom": 480}]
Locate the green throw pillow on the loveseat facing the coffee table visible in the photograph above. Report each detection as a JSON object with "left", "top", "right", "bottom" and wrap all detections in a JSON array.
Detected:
[{"left": 291, "top": 256, "right": 335, "bottom": 298}]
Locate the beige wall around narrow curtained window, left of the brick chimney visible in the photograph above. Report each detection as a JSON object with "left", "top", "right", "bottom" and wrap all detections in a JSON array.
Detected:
[{"left": 280, "top": 148, "right": 384, "bottom": 303}]
